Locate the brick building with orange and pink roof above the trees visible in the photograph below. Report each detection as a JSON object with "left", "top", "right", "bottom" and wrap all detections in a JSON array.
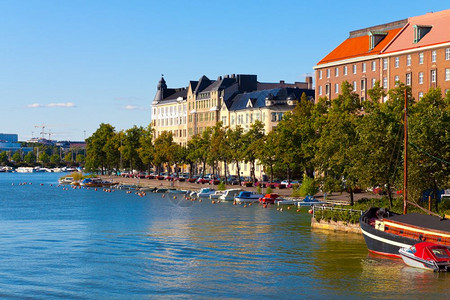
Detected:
[{"left": 314, "top": 10, "right": 450, "bottom": 100}]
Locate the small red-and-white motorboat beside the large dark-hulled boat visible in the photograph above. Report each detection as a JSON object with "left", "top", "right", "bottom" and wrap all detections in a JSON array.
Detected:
[{"left": 398, "top": 242, "right": 450, "bottom": 272}]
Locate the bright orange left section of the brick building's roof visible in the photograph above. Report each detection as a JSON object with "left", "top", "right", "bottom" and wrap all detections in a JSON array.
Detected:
[{"left": 318, "top": 28, "right": 401, "bottom": 65}]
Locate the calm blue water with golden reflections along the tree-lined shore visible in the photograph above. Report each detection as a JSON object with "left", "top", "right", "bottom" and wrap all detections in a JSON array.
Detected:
[{"left": 0, "top": 173, "right": 450, "bottom": 299}]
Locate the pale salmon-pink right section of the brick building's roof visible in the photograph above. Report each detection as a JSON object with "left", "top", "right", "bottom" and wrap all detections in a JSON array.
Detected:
[{"left": 383, "top": 9, "right": 450, "bottom": 53}]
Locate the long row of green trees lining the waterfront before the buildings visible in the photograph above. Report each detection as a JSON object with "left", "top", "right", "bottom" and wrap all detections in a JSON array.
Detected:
[{"left": 86, "top": 82, "right": 450, "bottom": 206}]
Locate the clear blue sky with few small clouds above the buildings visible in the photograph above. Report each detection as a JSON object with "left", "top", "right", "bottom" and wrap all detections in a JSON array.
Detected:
[{"left": 0, "top": 0, "right": 450, "bottom": 140}]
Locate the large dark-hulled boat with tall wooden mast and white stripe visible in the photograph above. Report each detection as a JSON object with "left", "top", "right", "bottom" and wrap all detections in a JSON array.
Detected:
[{"left": 359, "top": 90, "right": 450, "bottom": 257}]
